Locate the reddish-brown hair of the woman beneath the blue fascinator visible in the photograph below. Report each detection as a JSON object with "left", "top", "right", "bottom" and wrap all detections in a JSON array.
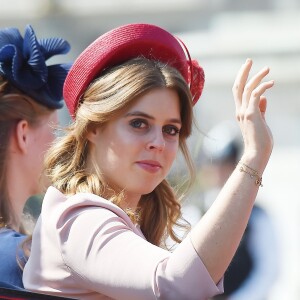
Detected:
[{"left": 0, "top": 76, "right": 53, "bottom": 233}]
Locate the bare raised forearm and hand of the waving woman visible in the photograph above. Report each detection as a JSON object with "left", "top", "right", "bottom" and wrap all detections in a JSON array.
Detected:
[{"left": 191, "top": 60, "right": 274, "bottom": 282}]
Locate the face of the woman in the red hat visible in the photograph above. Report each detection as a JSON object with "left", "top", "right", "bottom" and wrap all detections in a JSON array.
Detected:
[{"left": 88, "top": 89, "right": 181, "bottom": 206}]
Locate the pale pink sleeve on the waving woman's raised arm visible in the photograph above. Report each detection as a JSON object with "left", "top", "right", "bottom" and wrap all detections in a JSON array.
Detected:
[{"left": 59, "top": 208, "right": 223, "bottom": 300}]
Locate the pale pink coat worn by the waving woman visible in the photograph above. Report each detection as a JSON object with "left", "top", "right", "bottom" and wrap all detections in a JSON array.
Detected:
[{"left": 23, "top": 187, "right": 223, "bottom": 300}]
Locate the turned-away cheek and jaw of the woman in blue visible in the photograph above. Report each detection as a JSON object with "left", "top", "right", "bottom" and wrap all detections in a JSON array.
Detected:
[{"left": 28, "top": 111, "right": 58, "bottom": 194}]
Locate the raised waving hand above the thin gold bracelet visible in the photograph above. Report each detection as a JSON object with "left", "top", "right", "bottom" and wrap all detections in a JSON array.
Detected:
[{"left": 232, "top": 59, "right": 274, "bottom": 165}]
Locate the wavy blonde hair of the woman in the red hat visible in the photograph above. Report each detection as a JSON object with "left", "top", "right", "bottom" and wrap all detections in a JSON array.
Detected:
[{"left": 46, "top": 57, "right": 194, "bottom": 246}]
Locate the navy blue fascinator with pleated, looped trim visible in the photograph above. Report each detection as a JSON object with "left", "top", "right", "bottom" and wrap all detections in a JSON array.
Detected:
[{"left": 0, "top": 25, "right": 71, "bottom": 108}]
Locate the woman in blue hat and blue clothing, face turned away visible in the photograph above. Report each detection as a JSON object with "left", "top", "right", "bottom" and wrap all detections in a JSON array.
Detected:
[{"left": 0, "top": 25, "right": 70, "bottom": 287}]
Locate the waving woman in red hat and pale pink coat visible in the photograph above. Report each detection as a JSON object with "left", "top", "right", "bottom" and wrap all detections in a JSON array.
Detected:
[{"left": 23, "top": 24, "right": 273, "bottom": 300}]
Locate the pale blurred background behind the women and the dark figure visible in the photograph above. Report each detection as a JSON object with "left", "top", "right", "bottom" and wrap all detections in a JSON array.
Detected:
[{"left": 0, "top": 0, "right": 300, "bottom": 300}]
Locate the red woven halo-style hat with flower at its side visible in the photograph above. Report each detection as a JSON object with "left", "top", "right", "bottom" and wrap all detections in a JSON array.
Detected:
[{"left": 63, "top": 24, "right": 204, "bottom": 117}]
